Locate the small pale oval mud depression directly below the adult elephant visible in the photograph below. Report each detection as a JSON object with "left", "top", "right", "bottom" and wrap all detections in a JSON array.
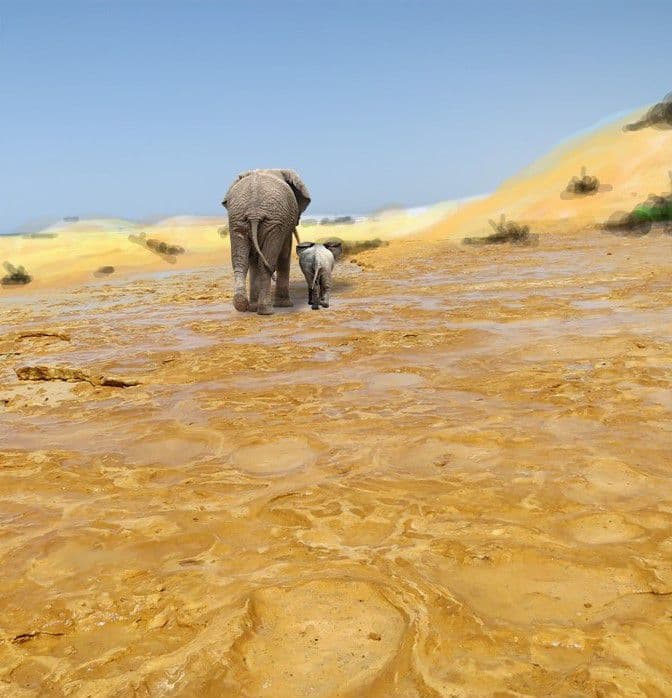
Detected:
[{"left": 233, "top": 437, "right": 317, "bottom": 475}]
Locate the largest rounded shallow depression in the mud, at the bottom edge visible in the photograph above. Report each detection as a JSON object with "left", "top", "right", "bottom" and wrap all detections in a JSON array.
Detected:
[{"left": 228, "top": 579, "right": 406, "bottom": 698}]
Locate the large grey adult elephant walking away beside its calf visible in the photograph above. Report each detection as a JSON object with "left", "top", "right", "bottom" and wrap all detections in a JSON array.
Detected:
[{"left": 222, "top": 170, "right": 310, "bottom": 315}]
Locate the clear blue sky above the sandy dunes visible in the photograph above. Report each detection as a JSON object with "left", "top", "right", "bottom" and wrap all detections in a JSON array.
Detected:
[{"left": 0, "top": 0, "right": 672, "bottom": 232}]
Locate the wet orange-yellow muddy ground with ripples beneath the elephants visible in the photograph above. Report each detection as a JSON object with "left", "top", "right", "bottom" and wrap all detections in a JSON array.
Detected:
[{"left": 0, "top": 232, "right": 672, "bottom": 697}]
